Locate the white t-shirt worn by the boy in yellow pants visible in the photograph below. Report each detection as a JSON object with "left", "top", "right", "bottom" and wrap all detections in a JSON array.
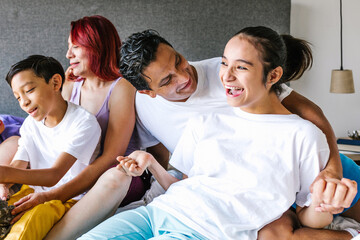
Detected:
[{"left": 14, "top": 102, "right": 101, "bottom": 199}]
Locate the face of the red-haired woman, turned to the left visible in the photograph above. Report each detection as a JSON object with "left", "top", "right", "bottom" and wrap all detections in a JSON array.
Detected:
[{"left": 66, "top": 36, "right": 93, "bottom": 78}]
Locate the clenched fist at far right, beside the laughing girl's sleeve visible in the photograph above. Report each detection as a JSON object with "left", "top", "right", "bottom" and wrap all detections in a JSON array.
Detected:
[{"left": 311, "top": 178, "right": 357, "bottom": 214}]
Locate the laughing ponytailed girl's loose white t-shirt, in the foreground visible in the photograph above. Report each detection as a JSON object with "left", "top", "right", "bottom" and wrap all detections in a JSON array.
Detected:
[{"left": 149, "top": 108, "right": 329, "bottom": 239}]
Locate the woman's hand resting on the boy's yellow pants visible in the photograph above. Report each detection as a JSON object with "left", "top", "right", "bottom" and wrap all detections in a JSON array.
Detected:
[{"left": 11, "top": 192, "right": 48, "bottom": 224}]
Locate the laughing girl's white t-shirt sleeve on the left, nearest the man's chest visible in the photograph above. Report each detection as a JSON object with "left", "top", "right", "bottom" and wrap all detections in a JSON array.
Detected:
[{"left": 170, "top": 118, "right": 203, "bottom": 175}]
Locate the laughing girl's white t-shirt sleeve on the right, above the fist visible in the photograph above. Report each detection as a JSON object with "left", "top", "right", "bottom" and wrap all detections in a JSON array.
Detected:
[{"left": 296, "top": 126, "right": 330, "bottom": 207}]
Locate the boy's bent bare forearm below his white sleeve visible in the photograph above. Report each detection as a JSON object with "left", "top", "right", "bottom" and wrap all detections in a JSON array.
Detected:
[{"left": 0, "top": 152, "right": 76, "bottom": 187}]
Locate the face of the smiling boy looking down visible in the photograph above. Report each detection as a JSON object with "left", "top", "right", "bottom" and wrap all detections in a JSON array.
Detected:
[{"left": 11, "top": 70, "right": 56, "bottom": 121}]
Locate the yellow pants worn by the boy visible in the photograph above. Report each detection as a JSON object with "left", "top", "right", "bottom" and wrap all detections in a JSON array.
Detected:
[{"left": 5, "top": 185, "right": 77, "bottom": 240}]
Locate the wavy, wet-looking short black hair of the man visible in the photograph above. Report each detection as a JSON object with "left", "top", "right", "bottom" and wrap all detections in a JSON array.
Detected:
[{"left": 120, "top": 29, "right": 172, "bottom": 90}]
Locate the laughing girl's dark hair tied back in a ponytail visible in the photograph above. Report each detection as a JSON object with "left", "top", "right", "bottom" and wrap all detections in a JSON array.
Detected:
[{"left": 234, "top": 26, "right": 313, "bottom": 93}]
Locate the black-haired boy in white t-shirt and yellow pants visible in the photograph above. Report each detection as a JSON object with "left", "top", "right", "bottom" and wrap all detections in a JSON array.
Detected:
[{"left": 0, "top": 55, "right": 101, "bottom": 239}]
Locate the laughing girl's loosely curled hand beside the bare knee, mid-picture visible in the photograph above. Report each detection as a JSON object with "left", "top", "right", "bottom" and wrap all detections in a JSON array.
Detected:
[{"left": 116, "top": 151, "right": 153, "bottom": 176}]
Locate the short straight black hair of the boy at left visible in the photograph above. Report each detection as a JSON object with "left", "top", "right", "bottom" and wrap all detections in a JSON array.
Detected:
[{"left": 5, "top": 55, "right": 65, "bottom": 90}]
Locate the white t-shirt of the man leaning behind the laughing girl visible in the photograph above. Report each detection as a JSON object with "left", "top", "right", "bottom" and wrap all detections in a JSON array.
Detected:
[{"left": 135, "top": 57, "right": 292, "bottom": 152}]
